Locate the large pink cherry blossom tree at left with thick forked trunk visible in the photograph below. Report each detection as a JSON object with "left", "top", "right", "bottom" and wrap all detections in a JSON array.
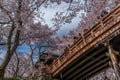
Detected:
[{"left": 0, "top": 0, "right": 78, "bottom": 77}]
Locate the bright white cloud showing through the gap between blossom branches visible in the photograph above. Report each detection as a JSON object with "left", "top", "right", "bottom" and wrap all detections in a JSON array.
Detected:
[{"left": 35, "top": 2, "right": 81, "bottom": 36}]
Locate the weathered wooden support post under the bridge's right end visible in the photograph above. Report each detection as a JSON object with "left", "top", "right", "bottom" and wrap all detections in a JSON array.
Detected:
[{"left": 108, "top": 43, "right": 120, "bottom": 80}]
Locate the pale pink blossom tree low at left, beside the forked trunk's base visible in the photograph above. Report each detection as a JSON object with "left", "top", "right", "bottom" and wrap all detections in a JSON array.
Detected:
[{"left": 5, "top": 52, "right": 34, "bottom": 78}]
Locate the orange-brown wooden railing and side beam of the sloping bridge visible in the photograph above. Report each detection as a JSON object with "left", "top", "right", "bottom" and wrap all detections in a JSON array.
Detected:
[{"left": 49, "top": 5, "right": 120, "bottom": 76}]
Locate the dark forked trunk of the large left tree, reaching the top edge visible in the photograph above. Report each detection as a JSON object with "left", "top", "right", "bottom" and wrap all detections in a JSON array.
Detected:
[{"left": 0, "top": 0, "right": 22, "bottom": 78}]
